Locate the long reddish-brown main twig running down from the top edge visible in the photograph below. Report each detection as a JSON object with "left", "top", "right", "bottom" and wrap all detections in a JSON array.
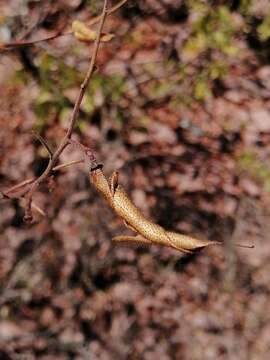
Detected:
[{"left": 21, "top": 0, "right": 108, "bottom": 222}]
